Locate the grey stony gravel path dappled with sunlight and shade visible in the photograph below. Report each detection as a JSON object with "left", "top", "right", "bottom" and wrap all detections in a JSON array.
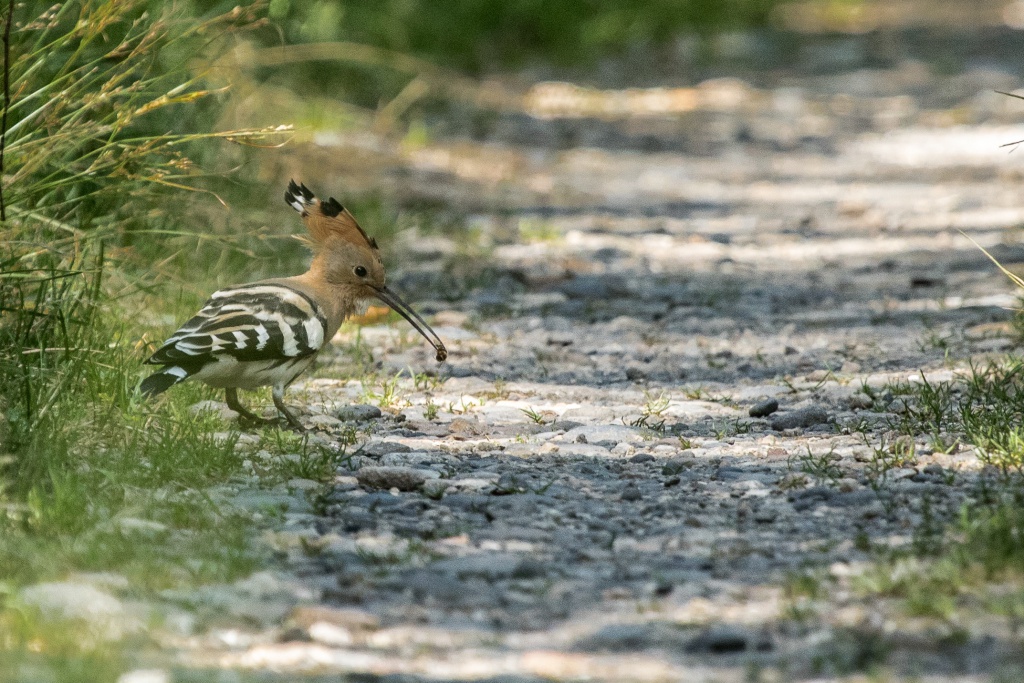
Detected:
[{"left": 99, "top": 28, "right": 1024, "bottom": 682}]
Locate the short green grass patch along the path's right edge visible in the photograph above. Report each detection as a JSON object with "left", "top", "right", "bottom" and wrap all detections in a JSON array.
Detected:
[{"left": 794, "top": 358, "right": 1024, "bottom": 671}]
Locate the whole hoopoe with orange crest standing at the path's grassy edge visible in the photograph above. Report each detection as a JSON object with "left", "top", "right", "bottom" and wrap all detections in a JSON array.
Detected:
[{"left": 139, "top": 180, "right": 447, "bottom": 431}]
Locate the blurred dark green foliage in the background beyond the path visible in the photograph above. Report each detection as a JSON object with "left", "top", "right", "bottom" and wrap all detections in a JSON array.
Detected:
[{"left": 247, "top": 0, "right": 778, "bottom": 73}]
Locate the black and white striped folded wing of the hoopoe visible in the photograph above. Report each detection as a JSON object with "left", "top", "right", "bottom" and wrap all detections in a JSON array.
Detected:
[{"left": 146, "top": 284, "right": 327, "bottom": 367}]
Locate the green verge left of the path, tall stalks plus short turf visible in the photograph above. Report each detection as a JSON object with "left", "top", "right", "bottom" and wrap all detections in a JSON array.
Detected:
[{"left": 0, "top": 0, "right": 292, "bottom": 593}]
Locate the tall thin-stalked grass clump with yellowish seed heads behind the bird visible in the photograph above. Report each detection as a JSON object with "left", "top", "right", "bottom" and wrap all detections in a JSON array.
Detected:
[{"left": 0, "top": 0, "right": 280, "bottom": 454}]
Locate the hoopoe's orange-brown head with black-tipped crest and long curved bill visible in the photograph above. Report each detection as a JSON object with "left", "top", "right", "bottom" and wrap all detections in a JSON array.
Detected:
[{"left": 285, "top": 180, "right": 447, "bottom": 362}]
